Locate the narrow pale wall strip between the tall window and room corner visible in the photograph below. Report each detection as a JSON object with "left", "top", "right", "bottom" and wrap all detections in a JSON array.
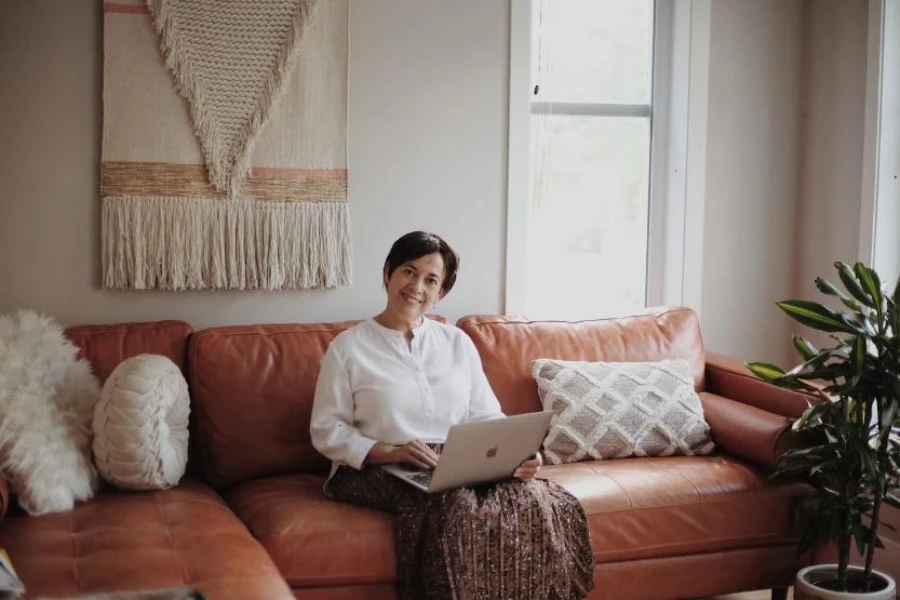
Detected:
[{"left": 700, "top": 0, "right": 803, "bottom": 362}]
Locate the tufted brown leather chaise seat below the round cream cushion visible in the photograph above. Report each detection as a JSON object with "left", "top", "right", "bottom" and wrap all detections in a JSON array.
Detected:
[{"left": 0, "top": 480, "right": 293, "bottom": 600}]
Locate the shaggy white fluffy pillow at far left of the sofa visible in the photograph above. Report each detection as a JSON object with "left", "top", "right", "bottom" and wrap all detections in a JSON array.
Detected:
[{"left": 0, "top": 311, "right": 100, "bottom": 515}]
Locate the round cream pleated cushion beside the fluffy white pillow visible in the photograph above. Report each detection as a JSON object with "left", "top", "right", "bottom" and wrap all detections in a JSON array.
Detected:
[{"left": 94, "top": 354, "right": 190, "bottom": 490}]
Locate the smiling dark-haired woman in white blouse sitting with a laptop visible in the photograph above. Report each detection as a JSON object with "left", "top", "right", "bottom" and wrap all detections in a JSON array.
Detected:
[{"left": 310, "top": 231, "right": 594, "bottom": 599}]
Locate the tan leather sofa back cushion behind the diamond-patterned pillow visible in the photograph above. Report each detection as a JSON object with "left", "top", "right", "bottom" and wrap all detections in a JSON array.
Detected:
[{"left": 457, "top": 308, "right": 705, "bottom": 415}]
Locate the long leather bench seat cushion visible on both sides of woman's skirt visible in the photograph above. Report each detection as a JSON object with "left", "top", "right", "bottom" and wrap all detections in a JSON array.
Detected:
[{"left": 226, "top": 456, "right": 804, "bottom": 588}]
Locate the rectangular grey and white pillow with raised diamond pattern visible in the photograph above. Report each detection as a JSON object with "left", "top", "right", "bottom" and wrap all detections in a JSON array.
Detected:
[{"left": 532, "top": 359, "right": 713, "bottom": 464}]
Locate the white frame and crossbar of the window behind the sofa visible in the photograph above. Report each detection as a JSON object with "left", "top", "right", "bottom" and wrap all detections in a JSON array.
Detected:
[{"left": 504, "top": 0, "right": 710, "bottom": 316}]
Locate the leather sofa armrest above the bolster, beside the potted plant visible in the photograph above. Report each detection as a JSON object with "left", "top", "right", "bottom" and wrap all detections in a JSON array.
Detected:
[{"left": 705, "top": 352, "right": 818, "bottom": 419}]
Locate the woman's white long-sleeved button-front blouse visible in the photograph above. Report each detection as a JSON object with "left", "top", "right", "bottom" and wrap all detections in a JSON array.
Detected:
[{"left": 309, "top": 318, "right": 504, "bottom": 473}]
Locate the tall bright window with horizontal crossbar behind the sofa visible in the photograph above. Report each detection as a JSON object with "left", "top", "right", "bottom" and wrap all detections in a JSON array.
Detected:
[{"left": 506, "top": 0, "right": 683, "bottom": 320}]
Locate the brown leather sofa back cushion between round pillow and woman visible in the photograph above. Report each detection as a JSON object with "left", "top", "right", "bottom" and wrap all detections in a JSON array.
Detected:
[{"left": 188, "top": 321, "right": 356, "bottom": 487}]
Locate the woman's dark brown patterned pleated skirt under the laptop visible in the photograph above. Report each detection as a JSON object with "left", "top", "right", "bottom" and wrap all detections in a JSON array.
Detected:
[{"left": 327, "top": 466, "right": 594, "bottom": 600}]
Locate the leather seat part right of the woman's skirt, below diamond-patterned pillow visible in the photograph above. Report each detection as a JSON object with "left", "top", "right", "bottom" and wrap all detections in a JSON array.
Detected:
[{"left": 541, "top": 456, "right": 804, "bottom": 563}]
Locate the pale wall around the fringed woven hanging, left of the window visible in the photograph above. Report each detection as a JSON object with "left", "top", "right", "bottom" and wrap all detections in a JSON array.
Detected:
[{"left": 0, "top": 0, "right": 509, "bottom": 327}]
